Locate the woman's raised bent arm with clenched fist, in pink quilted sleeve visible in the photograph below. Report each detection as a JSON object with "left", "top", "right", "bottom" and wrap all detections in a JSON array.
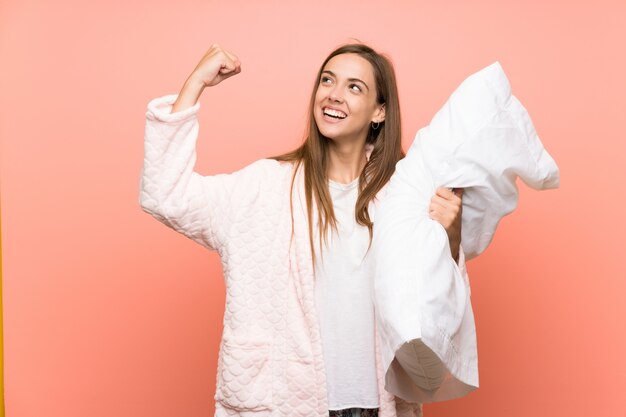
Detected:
[{"left": 139, "top": 45, "right": 247, "bottom": 249}]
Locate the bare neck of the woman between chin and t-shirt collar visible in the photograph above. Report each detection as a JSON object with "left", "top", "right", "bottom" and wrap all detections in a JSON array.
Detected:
[{"left": 328, "top": 140, "right": 367, "bottom": 184}]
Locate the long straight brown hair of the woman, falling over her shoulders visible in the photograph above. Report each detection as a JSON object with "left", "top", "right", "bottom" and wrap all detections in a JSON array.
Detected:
[{"left": 270, "top": 44, "right": 404, "bottom": 260}]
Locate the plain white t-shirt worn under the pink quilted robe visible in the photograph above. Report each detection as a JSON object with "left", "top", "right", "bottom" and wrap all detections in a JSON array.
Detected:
[{"left": 315, "top": 178, "right": 379, "bottom": 410}]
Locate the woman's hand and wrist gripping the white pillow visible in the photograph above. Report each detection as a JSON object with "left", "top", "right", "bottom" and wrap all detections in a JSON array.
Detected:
[{"left": 428, "top": 187, "right": 463, "bottom": 261}]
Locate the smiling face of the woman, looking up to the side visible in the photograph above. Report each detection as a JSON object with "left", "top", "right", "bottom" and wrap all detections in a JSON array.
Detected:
[{"left": 313, "top": 54, "right": 385, "bottom": 142}]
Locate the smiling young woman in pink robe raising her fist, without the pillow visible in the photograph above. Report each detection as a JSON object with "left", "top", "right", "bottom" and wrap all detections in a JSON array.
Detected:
[{"left": 140, "top": 44, "right": 461, "bottom": 417}]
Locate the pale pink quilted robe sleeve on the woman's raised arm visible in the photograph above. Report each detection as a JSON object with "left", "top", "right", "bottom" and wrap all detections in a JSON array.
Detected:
[{"left": 139, "top": 95, "right": 258, "bottom": 250}]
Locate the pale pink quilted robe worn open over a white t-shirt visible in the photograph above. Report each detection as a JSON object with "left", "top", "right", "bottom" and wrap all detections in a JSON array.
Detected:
[{"left": 140, "top": 95, "right": 422, "bottom": 417}]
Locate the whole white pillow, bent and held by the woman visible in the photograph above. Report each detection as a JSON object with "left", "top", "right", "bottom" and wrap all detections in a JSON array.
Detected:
[{"left": 372, "top": 62, "right": 559, "bottom": 402}]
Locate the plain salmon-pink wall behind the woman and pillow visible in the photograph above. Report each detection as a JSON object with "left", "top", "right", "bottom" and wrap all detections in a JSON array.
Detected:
[{"left": 0, "top": 0, "right": 626, "bottom": 417}]
